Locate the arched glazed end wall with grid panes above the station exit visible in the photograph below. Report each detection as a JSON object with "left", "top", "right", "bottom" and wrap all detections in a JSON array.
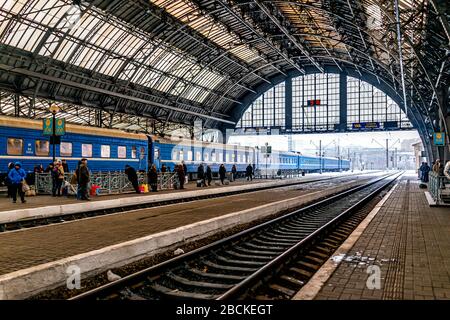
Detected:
[{"left": 236, "top": 73, "right": 412, "bottom": 133}]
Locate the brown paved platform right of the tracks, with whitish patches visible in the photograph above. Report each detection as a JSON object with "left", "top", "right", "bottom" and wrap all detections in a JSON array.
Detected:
[{"left": 294, "top": 175, "right": 450, "bottom": 300}]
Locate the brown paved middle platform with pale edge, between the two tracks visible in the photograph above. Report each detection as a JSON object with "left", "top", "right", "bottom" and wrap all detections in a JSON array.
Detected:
[{"left": 0, "top": 173, "right": 381, "bottom": 299}]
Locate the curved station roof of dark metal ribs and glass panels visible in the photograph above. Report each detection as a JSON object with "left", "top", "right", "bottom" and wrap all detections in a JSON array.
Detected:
[{"left": 0, "top": 0, "right": 450, "bottom": 152}]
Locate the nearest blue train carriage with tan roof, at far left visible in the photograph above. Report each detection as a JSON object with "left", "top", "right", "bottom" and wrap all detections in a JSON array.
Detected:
[{"left": 0, "top": 116, "right": 148, "bottom": 176}]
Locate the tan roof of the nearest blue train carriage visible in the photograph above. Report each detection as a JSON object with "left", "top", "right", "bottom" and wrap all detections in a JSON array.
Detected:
[{"left": 0, "top": 116, "right": 147, "bottom": 140}]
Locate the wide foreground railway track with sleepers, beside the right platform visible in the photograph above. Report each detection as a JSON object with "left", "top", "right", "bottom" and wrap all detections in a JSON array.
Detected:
[{"left": 72, "top": 174, "right": 400, "bottom": 300}]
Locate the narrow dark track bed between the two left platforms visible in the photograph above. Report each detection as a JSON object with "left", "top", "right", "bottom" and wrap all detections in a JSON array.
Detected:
[{"left": 0, "top": 175, "right": 372, "bottom": 233}]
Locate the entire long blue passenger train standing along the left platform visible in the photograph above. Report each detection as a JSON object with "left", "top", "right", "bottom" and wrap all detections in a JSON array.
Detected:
[{"left": 0, "top": 116, "right": 350, "bottom": 177}]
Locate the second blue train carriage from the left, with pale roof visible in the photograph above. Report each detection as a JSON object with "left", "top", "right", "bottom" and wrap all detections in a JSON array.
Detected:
[{"left": 149, "top": 136, "right": 255, "bottom": 178}]
